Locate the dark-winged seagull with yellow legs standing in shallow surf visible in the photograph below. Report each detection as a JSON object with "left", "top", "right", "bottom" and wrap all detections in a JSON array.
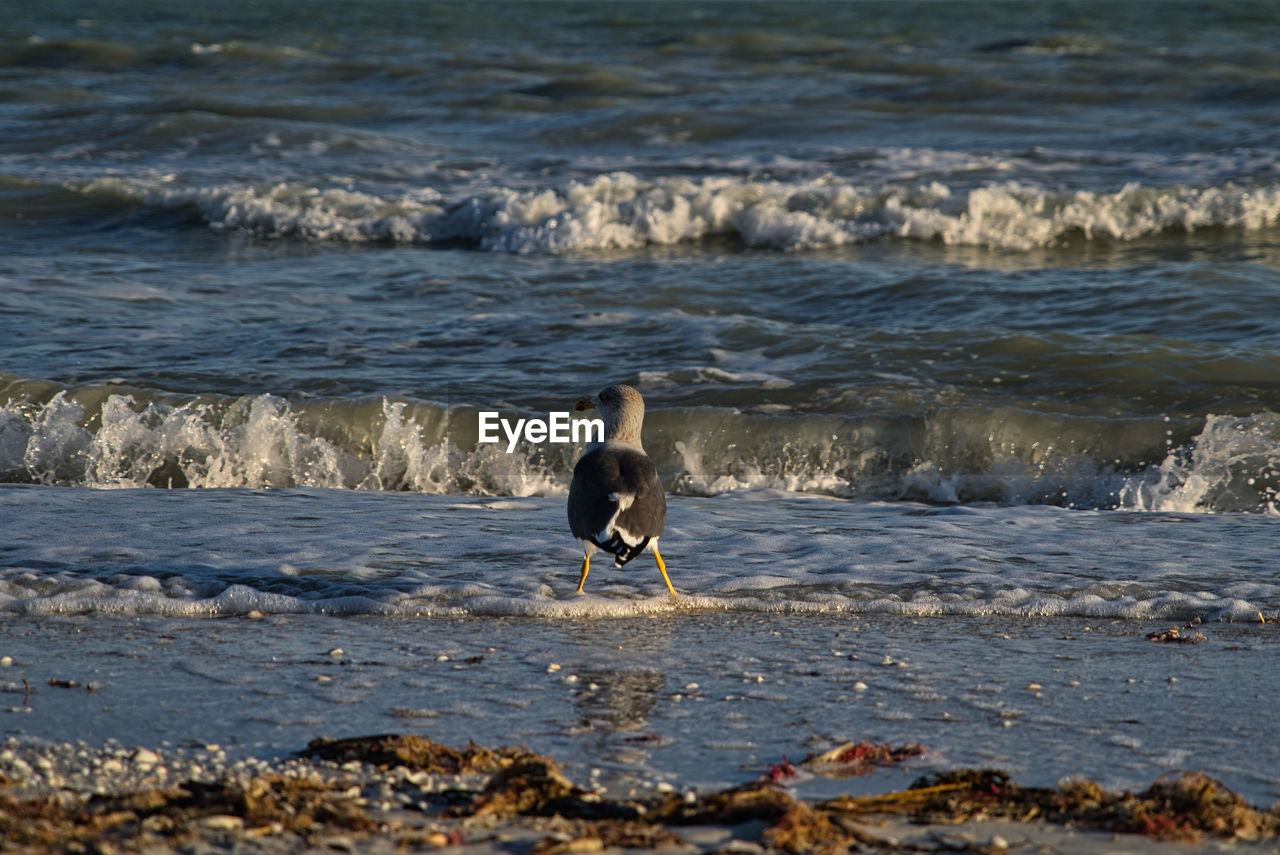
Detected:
[{"left": 568, "top": 385, "right": 678, "bottom": 596}]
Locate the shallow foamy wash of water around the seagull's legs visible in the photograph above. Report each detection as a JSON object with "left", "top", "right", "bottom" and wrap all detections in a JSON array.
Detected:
[{"left": 0, "top": 486, "right": 1280, "bottom": 622}]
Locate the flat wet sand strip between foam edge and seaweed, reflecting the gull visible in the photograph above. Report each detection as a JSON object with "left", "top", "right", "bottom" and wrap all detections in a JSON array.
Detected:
[{"left": 0, "top": 606, "right": 1280, "bottom": 805}]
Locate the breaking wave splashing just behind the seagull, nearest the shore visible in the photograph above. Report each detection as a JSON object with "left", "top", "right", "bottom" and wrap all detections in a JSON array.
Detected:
[{"left": 0, "top": 384, "right": 1280, "bottom": 513}]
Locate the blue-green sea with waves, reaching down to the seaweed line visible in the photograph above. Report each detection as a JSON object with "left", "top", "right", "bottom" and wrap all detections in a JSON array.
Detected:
[{"left": 0, "top": 0, "right": 1280, "bottom": 804}]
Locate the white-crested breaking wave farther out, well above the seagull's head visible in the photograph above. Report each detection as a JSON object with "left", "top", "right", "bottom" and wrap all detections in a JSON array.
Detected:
[{"left": 70, "top": 172, "right": 1280, "bottom": 253}]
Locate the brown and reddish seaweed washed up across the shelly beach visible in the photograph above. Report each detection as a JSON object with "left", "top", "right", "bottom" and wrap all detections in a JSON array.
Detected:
[{"left": 0, "top": 736, "right": 1280, "bottom": 855}]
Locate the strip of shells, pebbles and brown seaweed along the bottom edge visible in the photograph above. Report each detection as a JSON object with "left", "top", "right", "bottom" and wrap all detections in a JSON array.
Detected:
[{"left": 0, "top": 735, "right": 1280, "bottom": 855}]
